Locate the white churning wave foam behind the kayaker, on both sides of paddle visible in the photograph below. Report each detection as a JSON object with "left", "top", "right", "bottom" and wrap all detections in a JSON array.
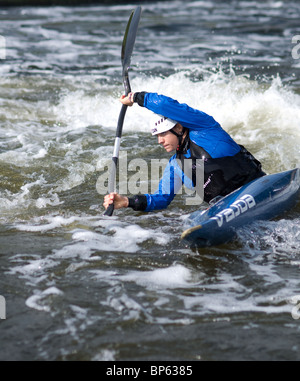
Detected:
[{"left": 44, "top": 70, "right": 300, "bottom": 170}]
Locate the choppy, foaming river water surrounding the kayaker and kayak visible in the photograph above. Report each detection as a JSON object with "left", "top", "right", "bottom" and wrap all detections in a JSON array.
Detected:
[{"left": 0, "top": 0, "right": 300, "bottom": 361}]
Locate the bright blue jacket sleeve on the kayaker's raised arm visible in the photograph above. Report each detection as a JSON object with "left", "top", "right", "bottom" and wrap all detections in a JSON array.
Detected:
[{"left": 138, "top": 92, "right": 219, "bottom": 130}]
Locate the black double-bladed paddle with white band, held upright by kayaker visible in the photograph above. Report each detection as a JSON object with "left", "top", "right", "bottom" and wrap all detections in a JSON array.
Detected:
[{"left": 104, "top": 6, "right": 142, "bottom": 216}]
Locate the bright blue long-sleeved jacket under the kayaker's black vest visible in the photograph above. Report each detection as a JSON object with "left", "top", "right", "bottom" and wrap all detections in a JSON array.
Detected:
[{"left": 144, "top": 93, "right": 241, "bottom": 211}]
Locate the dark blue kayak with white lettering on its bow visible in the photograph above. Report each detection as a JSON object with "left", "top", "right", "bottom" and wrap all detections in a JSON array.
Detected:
[{"left": 181, "top": 168, "right": 300, "bottom": 247}]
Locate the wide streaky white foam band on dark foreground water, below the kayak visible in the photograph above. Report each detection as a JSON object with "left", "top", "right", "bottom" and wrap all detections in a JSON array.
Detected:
[{"left": 91, "top": 258, "right": 296, "bottom": 325}]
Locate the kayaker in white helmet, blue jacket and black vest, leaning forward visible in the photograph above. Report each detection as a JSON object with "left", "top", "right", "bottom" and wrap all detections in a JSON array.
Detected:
[{"left": 103, "top": 91, "right": 265, "bottom": 211}]
